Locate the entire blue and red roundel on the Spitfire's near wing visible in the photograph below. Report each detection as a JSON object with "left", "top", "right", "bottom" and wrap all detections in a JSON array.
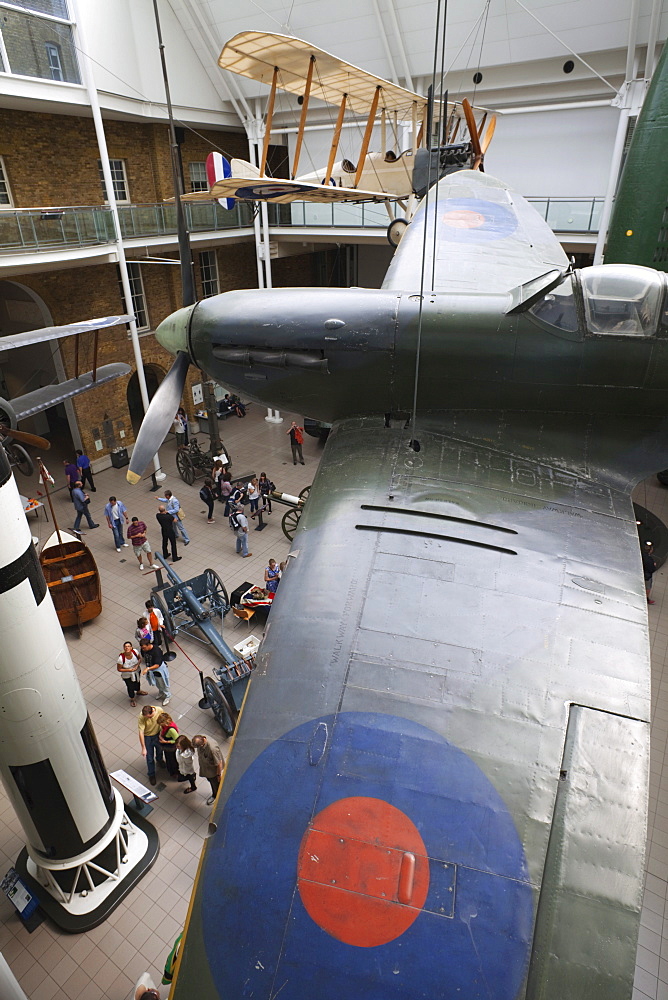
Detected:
[{"left": 201, "top": 712, "right": 534, "bottom": 1000}]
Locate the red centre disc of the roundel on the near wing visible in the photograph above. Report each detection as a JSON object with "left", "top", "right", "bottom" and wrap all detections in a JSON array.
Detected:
[{"left": 297, "top": 796, "right": 429, "bottom": 948}]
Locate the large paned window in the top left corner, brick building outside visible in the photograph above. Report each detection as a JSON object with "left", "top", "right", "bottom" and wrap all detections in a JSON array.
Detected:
[{"left": 0, "top": 6, "right": 81, "bottom": 83}]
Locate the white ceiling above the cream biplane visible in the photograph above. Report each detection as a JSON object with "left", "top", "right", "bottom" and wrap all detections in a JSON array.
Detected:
[{"left": 168, "top": 0, "right": 668, "bottom": 112}]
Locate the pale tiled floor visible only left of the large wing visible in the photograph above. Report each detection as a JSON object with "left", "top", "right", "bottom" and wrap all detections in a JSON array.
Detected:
[{"left": 0, "top": 406, "right": 322, "bottom": 1000}]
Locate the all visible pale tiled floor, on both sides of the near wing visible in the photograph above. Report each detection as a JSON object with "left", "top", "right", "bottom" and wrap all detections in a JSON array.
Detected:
[{"left": 0, "top": 407, "right": 668, "bottom": 1000}]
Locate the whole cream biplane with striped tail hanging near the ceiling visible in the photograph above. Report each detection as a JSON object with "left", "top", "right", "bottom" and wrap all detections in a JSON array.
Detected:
[{"left": 182, "top": 31, "right": 495, "bottom": 217}]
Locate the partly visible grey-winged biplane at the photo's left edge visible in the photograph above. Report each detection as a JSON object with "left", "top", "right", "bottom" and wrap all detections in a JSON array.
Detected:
[{"left": 0, "top": 315, "right": 131, "bottom": 436}]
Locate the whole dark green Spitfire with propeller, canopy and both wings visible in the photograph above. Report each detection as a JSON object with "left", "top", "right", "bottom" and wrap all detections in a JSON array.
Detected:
[{"left": 129, "top": 170, "right": 668, "bottom": 1000}]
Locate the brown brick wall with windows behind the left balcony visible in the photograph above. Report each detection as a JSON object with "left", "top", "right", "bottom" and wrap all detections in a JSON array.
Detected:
[{"left": 0, "top": 109, "right": 313, "bottom": 466}]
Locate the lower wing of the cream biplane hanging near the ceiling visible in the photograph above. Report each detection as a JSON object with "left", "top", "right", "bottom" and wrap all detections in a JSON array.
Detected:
[{"left": 181, "top": 177, "right": 397, "bottom": 205}]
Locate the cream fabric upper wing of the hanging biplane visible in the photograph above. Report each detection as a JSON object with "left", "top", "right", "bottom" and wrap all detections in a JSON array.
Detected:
[{"left": 218, "top": 31, "right": 427, "bottom": 119}]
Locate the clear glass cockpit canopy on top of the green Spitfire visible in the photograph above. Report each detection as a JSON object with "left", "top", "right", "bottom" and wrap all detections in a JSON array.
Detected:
[{"left": 529, "top": 264, "right": 665, "bottom": 337}]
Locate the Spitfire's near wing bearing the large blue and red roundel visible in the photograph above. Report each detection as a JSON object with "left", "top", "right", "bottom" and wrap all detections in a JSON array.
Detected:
[{"left": 172, "top": 411, "right": 649, "bottom": 1000}]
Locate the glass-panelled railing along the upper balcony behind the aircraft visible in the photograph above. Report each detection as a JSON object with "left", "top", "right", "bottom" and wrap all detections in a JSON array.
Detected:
[{"left": 0, "top": 198, "right": 603, "bottom": 254}]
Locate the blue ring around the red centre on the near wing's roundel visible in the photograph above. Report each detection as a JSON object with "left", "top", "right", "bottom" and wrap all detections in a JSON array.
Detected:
[{"left": 200, "top": 712, "right": 534, "bottom": 1000}]
